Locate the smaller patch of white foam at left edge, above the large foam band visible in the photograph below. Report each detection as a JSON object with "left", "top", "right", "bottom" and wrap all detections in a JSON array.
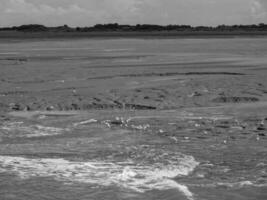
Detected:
[{"left": 0, "top": 122, "right": 68, "bottom": 138}]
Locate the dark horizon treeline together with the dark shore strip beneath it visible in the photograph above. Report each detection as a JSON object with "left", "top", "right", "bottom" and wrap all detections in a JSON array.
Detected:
[{"left": 0, "top": 23, "right": 267, "bottom": 39}]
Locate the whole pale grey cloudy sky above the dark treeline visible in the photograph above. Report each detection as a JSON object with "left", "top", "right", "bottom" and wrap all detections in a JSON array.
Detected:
[{"left": 0, "top": 0, "right": 267, "bottom": 27}]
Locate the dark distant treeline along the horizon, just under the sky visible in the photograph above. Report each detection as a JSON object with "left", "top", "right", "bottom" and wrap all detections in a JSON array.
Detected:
[{"left": 0, "top": 23, "right": 267, "bottom": 32}]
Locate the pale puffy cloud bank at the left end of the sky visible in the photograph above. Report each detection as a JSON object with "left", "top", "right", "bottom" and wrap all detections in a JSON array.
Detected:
[{"left": 0, "top": 0, "right": 96, "bottom": 26}]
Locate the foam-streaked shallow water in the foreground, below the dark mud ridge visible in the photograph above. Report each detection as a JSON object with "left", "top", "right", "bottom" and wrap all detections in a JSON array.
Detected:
[{"left": 0, "top": 106, "right": 267, "bottom": 199}]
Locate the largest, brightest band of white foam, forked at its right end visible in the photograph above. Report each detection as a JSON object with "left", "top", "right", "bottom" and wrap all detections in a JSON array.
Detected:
[{"left": 0, "top": 154, "right": 198, "bottom": 200}]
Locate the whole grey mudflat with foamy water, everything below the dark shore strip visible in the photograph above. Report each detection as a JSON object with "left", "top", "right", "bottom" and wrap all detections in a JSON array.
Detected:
[{"left": 0, "top": 37, "right": 267, "bottom": 200}]
